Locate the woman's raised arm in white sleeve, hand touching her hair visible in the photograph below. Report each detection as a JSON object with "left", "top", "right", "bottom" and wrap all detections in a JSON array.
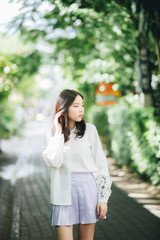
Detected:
[{"left": 42, "top": 112, "right": 64, "bottom": 168}]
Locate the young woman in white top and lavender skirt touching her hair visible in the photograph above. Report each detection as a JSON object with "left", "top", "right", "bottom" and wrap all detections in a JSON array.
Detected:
[{"left": 43, "top": 89, "right": 112, "bottom": 240}]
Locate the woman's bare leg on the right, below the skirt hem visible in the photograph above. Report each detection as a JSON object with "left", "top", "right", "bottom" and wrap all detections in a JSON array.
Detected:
[{"left": 78, "top": 223, "right": 96, "bottom": 240}]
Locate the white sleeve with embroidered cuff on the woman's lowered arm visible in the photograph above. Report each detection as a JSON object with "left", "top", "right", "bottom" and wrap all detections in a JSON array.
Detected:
[{"left": 90, "top": 125, "right": 112, "bottom": 202}]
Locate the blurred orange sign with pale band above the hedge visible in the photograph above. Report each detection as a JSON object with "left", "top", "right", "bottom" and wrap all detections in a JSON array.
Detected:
[{"left": 96, "top": 82, "right": 121, "bottom": 106}]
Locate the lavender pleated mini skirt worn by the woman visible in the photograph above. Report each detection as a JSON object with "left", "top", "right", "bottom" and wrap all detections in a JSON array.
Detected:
[{"left": 50, "top": 172, "right": 106, "bottom": 226}]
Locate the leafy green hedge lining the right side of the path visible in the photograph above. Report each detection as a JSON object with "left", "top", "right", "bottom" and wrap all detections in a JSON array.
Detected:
[{"left": 108, "top": 96, "right": 160, "bottom": 184}]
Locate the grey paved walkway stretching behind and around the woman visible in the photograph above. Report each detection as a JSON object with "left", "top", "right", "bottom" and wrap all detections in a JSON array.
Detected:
[{"left": 0, "top": 123, "right": 160, "bottom": 240}]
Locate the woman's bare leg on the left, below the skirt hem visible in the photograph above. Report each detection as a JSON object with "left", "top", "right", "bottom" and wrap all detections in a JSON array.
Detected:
[{"left": 55, "top": 225, "right": 73, "bottom": 240}]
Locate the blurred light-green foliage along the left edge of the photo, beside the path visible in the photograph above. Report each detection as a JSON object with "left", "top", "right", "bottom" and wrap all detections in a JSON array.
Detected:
[{"left": 0, "top": 36, "right": 41, "bottom": 137}]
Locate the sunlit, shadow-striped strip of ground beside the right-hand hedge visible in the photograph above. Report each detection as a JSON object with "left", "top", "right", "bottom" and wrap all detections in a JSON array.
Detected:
[{"left": 108, "top": 158, "right": 160, "bottom": 218}]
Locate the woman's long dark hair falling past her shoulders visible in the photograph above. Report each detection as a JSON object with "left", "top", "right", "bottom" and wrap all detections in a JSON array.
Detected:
[{"left": 52, "top": 89, "right": 86, "bottom": 142}]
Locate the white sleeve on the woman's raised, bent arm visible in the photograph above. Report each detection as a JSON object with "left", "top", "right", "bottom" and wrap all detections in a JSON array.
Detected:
[{"left": 42, "top": 131, "right": 64, "bottom": 168}]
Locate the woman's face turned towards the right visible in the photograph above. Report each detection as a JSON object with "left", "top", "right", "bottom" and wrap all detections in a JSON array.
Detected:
[{"left": 68, "top": 95, "right": 84, "bottom": 122}]
